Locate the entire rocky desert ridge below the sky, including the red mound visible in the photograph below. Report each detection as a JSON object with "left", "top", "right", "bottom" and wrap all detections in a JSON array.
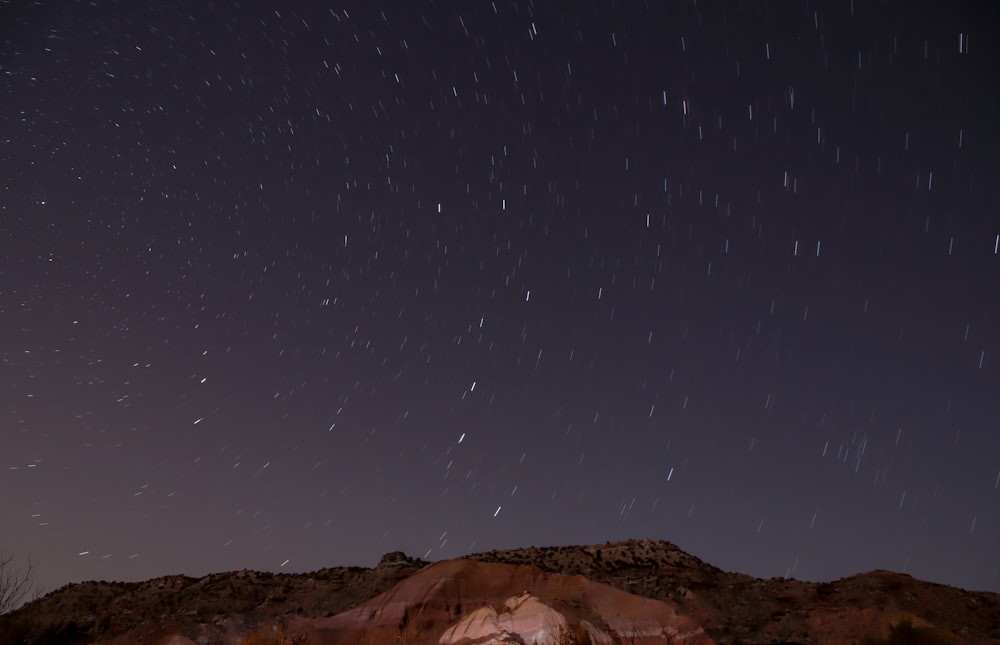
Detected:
[{"left": 0, "top": 540, "right": 1000, "bottom": 645}]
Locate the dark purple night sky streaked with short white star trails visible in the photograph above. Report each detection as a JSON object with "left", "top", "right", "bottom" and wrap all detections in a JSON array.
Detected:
[{"left": 0, "top": 0, "right": 1000, "bottom": 591}]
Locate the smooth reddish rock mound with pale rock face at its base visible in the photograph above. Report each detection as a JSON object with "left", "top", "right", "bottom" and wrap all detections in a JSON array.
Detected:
[{"left": 312, "top": 560, "right": 712, "bottom": 645}]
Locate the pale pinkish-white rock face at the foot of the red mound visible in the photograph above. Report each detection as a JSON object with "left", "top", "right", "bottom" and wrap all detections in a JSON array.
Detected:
[{"left": 438, "top": 592, "right": 569, "bottom": 645}]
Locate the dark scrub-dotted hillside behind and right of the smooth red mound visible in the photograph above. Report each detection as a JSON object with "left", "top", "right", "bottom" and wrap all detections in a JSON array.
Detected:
[{"left": 471, "top": 540, "right": 1000, "bottom": 643}]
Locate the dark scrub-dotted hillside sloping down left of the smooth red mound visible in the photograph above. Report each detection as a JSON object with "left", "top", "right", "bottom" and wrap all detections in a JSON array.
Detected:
[{"left": 0, "top": 552, "right": 428, "bottom": 645}]
